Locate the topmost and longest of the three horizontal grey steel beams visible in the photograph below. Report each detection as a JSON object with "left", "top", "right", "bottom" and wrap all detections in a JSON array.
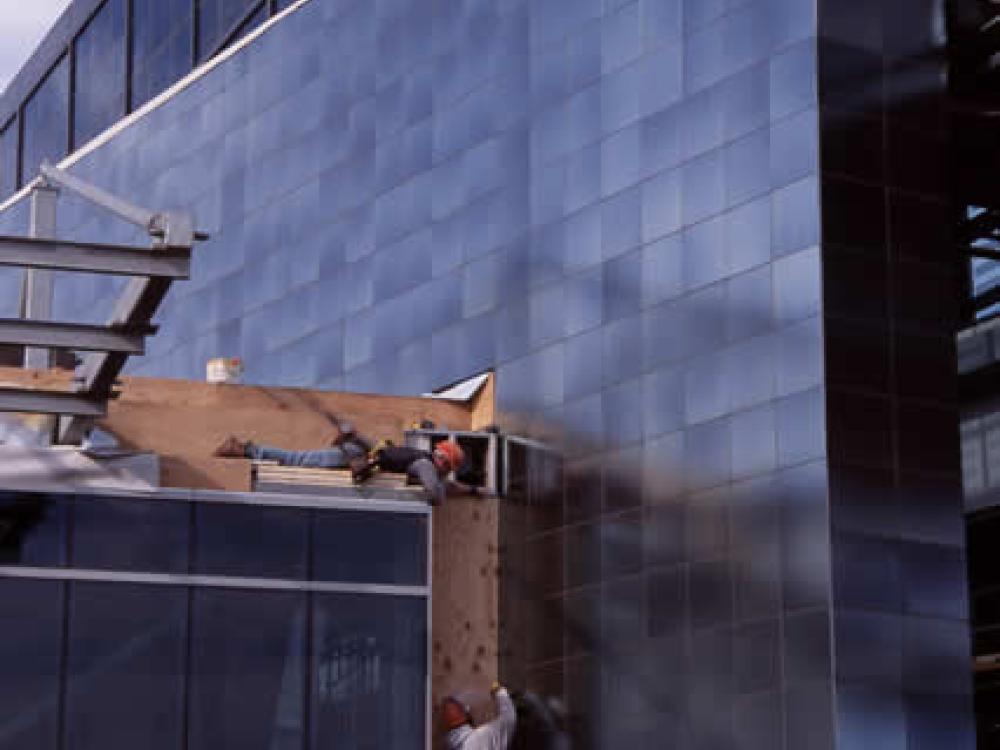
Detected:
[{"left": 0, "top": 236, "right": 191, "bottom": 279}]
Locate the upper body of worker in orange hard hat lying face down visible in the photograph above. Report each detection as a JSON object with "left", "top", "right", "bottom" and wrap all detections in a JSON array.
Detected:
[{"left": 351, "top": 440, "right": 479, "bottom": 505}]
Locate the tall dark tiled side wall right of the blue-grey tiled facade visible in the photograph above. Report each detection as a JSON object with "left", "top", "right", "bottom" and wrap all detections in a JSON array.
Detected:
[{"left": 819, "top": 0, "right": 975, "bottom": 748}]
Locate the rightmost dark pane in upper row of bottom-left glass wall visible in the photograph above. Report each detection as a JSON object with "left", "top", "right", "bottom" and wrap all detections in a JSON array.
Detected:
[{"left": 313, "top": 511, "right": 427, "bottom": 586}]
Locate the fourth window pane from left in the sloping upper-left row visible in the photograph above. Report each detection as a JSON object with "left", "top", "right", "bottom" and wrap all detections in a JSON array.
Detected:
[{"left": 132, "top": 0, "right": 193, "bottom": 109}]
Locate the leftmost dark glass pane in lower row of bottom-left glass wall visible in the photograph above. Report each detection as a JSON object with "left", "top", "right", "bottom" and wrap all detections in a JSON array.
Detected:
[{"left": 0, "top": 579, "right": 63, "bottom": 750}]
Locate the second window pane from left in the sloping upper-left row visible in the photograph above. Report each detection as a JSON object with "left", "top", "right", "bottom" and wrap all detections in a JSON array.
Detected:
[{"left": 21, "top": 55, "right": 69, "bottom": 182}]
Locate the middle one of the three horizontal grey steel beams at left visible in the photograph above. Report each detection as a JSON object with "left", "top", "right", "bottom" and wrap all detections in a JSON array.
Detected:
[{"left": 0, "top": 318, "right": 154, "bottom": 354}]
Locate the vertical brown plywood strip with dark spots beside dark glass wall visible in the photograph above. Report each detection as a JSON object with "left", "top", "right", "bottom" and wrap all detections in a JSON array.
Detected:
[{"left": 431, "top": 497, "right": 502, "bottom": 736}]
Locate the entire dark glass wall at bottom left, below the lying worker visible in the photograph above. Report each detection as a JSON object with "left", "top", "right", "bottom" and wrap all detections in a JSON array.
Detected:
[{"left": 0, "top": 493, "right": 428, "bottom": 750}]
